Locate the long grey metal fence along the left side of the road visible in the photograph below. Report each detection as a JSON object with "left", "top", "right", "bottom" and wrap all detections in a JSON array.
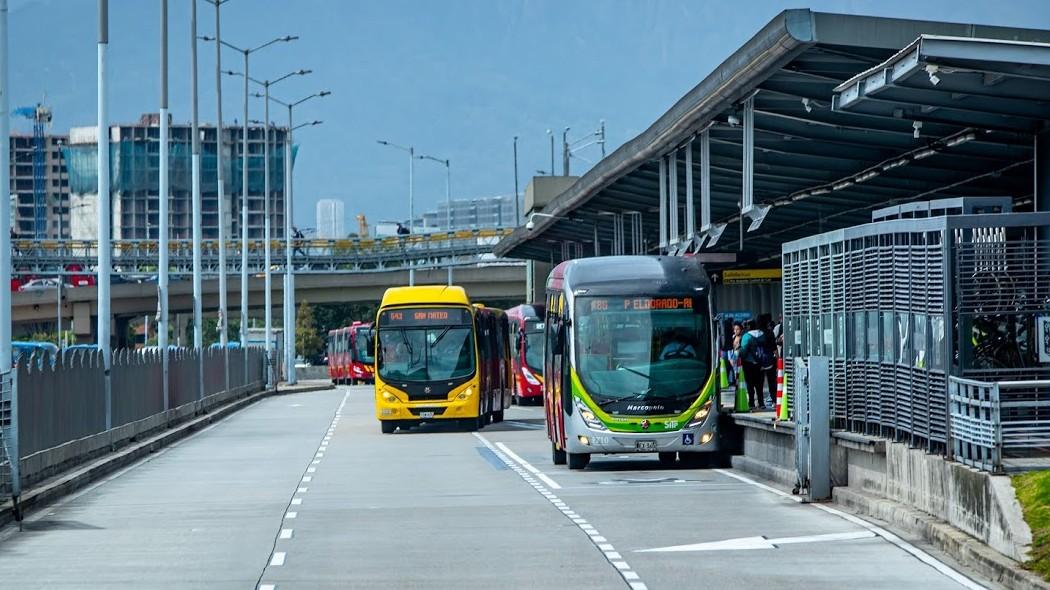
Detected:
[{"left": 0, "top": 347, "right": 264, "bottom": 493}]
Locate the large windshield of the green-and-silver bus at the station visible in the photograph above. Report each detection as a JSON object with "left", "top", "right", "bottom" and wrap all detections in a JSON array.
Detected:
[{"left": 573, "top": 296, "right": 711, "bottom": 414}]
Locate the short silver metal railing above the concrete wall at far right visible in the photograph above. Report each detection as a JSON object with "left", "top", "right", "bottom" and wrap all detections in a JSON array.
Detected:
[{"left": 948, "top": 376, "right": 1050, "bottom": 472}]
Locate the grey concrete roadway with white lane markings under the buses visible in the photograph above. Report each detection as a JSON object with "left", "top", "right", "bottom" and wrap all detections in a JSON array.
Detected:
[{"left": 0, "top": 386, "right": 995, "bottom": 590}]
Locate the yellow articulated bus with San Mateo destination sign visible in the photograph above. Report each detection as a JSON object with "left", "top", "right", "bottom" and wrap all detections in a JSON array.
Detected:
[{"left": 376, "top": 286, "right": 512, "bottom": 434}]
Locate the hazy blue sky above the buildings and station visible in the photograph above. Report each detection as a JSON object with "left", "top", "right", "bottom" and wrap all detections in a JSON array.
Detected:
[{"left": 9, "top": 0, "right": 1050, "bottom": 228}]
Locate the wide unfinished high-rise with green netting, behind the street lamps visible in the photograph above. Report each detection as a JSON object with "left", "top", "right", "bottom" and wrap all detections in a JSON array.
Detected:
[{"left": 65, "top": 113, "right": 295, "bottom": 239}]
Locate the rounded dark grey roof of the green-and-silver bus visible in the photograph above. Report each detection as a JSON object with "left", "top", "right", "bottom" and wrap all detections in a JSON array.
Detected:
[{"left": 548, "top": 256, "right": 711, "bottom": 295}]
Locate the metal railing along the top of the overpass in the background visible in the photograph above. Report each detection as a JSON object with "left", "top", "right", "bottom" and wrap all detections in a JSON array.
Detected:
[{"left": 12, "top": 228, "right": 512, "bottom": 275}]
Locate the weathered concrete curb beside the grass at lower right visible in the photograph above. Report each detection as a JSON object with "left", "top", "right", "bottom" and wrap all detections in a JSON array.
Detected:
[{"left": 832, "top": 487, "right": 1050, "bottom": 590}]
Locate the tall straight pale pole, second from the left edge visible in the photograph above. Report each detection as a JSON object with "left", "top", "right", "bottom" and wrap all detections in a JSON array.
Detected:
[{"left": 97, "top": 0, "right": 113, "bottom": 430}]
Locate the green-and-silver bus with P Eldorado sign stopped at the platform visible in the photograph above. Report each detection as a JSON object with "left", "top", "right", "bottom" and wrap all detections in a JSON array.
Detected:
[{"left": 544, "top": 256, "right": 720, "bottom": 469}]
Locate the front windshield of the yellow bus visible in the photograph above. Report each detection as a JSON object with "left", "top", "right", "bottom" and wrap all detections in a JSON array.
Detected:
[{"left": 376, "top": 308, "right": 475, "bottom": 381}]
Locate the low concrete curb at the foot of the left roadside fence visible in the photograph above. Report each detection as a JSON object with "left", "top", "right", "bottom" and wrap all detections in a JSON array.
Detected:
[{"left": 0, "top": 384, "right": 335, "bottom": 527}]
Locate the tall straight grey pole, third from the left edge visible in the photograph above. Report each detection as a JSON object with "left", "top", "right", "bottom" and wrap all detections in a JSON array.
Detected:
[{"left": 156, "top": 0, "right": 171, "bottom": 410}]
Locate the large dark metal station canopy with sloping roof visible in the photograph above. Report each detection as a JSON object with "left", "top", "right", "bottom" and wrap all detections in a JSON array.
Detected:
[{"left": 497, "top": 9, "right": 1050, "bottom": 266}]
